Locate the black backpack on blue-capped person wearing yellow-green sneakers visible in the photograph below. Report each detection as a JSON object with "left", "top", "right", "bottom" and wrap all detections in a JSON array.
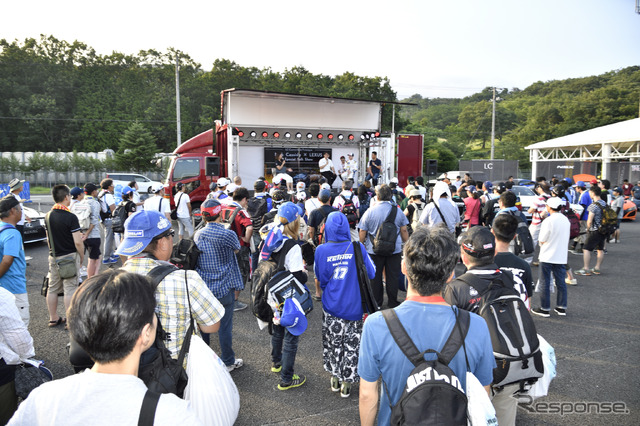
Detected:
[{"left": 251, "top": 239, "right": 297, "bottom": 334}]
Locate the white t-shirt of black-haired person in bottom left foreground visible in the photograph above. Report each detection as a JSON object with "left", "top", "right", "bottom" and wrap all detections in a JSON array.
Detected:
[{"left": 8, "top": 370, "right": 202, "bottom": 426}]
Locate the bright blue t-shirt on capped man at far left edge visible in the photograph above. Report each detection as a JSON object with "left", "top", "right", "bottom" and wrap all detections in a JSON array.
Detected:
[{"left": 0, "top": 222, "right": 27, "bottom": 294}]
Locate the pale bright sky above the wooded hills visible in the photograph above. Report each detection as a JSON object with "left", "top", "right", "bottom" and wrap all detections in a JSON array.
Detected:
[{"left": 0, "top": 0, "right": 640, "bottom": 99}]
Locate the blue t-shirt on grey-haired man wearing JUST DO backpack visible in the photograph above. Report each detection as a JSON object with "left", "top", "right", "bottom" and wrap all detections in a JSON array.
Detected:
[{"left": 358, "top": 301, "right": 496, "bottom": 425}]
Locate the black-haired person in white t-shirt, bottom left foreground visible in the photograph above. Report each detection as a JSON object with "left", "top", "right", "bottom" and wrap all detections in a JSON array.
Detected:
[{"left": 9, "top": 270, "right": 202, "bottom": 425}]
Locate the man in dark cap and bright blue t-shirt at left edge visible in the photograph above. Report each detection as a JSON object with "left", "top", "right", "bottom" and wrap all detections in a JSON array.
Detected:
[{"left": 0, "top": 194, "right": 29, "bottom": 327}]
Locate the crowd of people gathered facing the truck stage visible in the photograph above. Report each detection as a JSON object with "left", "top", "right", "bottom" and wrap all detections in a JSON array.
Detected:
[{"left": 0, "top": 169, "right": 640, "bottom": 424}]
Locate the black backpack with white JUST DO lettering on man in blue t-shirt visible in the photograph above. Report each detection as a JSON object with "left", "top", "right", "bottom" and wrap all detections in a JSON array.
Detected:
[{"left": 382, "top": 308, "right": 470, "bottom": 425}]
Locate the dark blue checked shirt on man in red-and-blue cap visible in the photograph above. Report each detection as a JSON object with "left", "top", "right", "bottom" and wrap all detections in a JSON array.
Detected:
[{"left": 193, "top": 222, "right": 244, "bottom": 298}]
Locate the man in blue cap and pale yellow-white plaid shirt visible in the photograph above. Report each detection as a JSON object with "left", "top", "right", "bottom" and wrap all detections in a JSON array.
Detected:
[{"left": 116, "top": 209, "right": 224, "bottom": 358}]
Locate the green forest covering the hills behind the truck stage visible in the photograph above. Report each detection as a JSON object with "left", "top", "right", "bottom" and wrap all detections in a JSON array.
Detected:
[{"left": 0, "top": 35, "right": 640, "bottom": 170}]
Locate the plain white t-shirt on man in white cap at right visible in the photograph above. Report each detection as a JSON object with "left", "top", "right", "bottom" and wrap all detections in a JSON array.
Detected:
[{"left": 538, "top": 212, "right": 571, "bottom": 265}]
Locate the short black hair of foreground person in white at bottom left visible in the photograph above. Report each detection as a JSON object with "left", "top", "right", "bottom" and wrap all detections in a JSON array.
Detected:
[{"left": 68, "top": 269, "right": 156, "bottom": 363}]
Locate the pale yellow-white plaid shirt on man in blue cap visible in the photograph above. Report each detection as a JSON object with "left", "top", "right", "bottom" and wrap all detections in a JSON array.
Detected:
[{"left": 122, "top": 257, "right": 224, "bottom": 358}]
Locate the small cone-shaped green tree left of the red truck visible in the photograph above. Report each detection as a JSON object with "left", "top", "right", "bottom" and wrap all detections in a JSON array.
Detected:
[{"left": 115, "top": 122, "right": 158, "bottom": 173}]
